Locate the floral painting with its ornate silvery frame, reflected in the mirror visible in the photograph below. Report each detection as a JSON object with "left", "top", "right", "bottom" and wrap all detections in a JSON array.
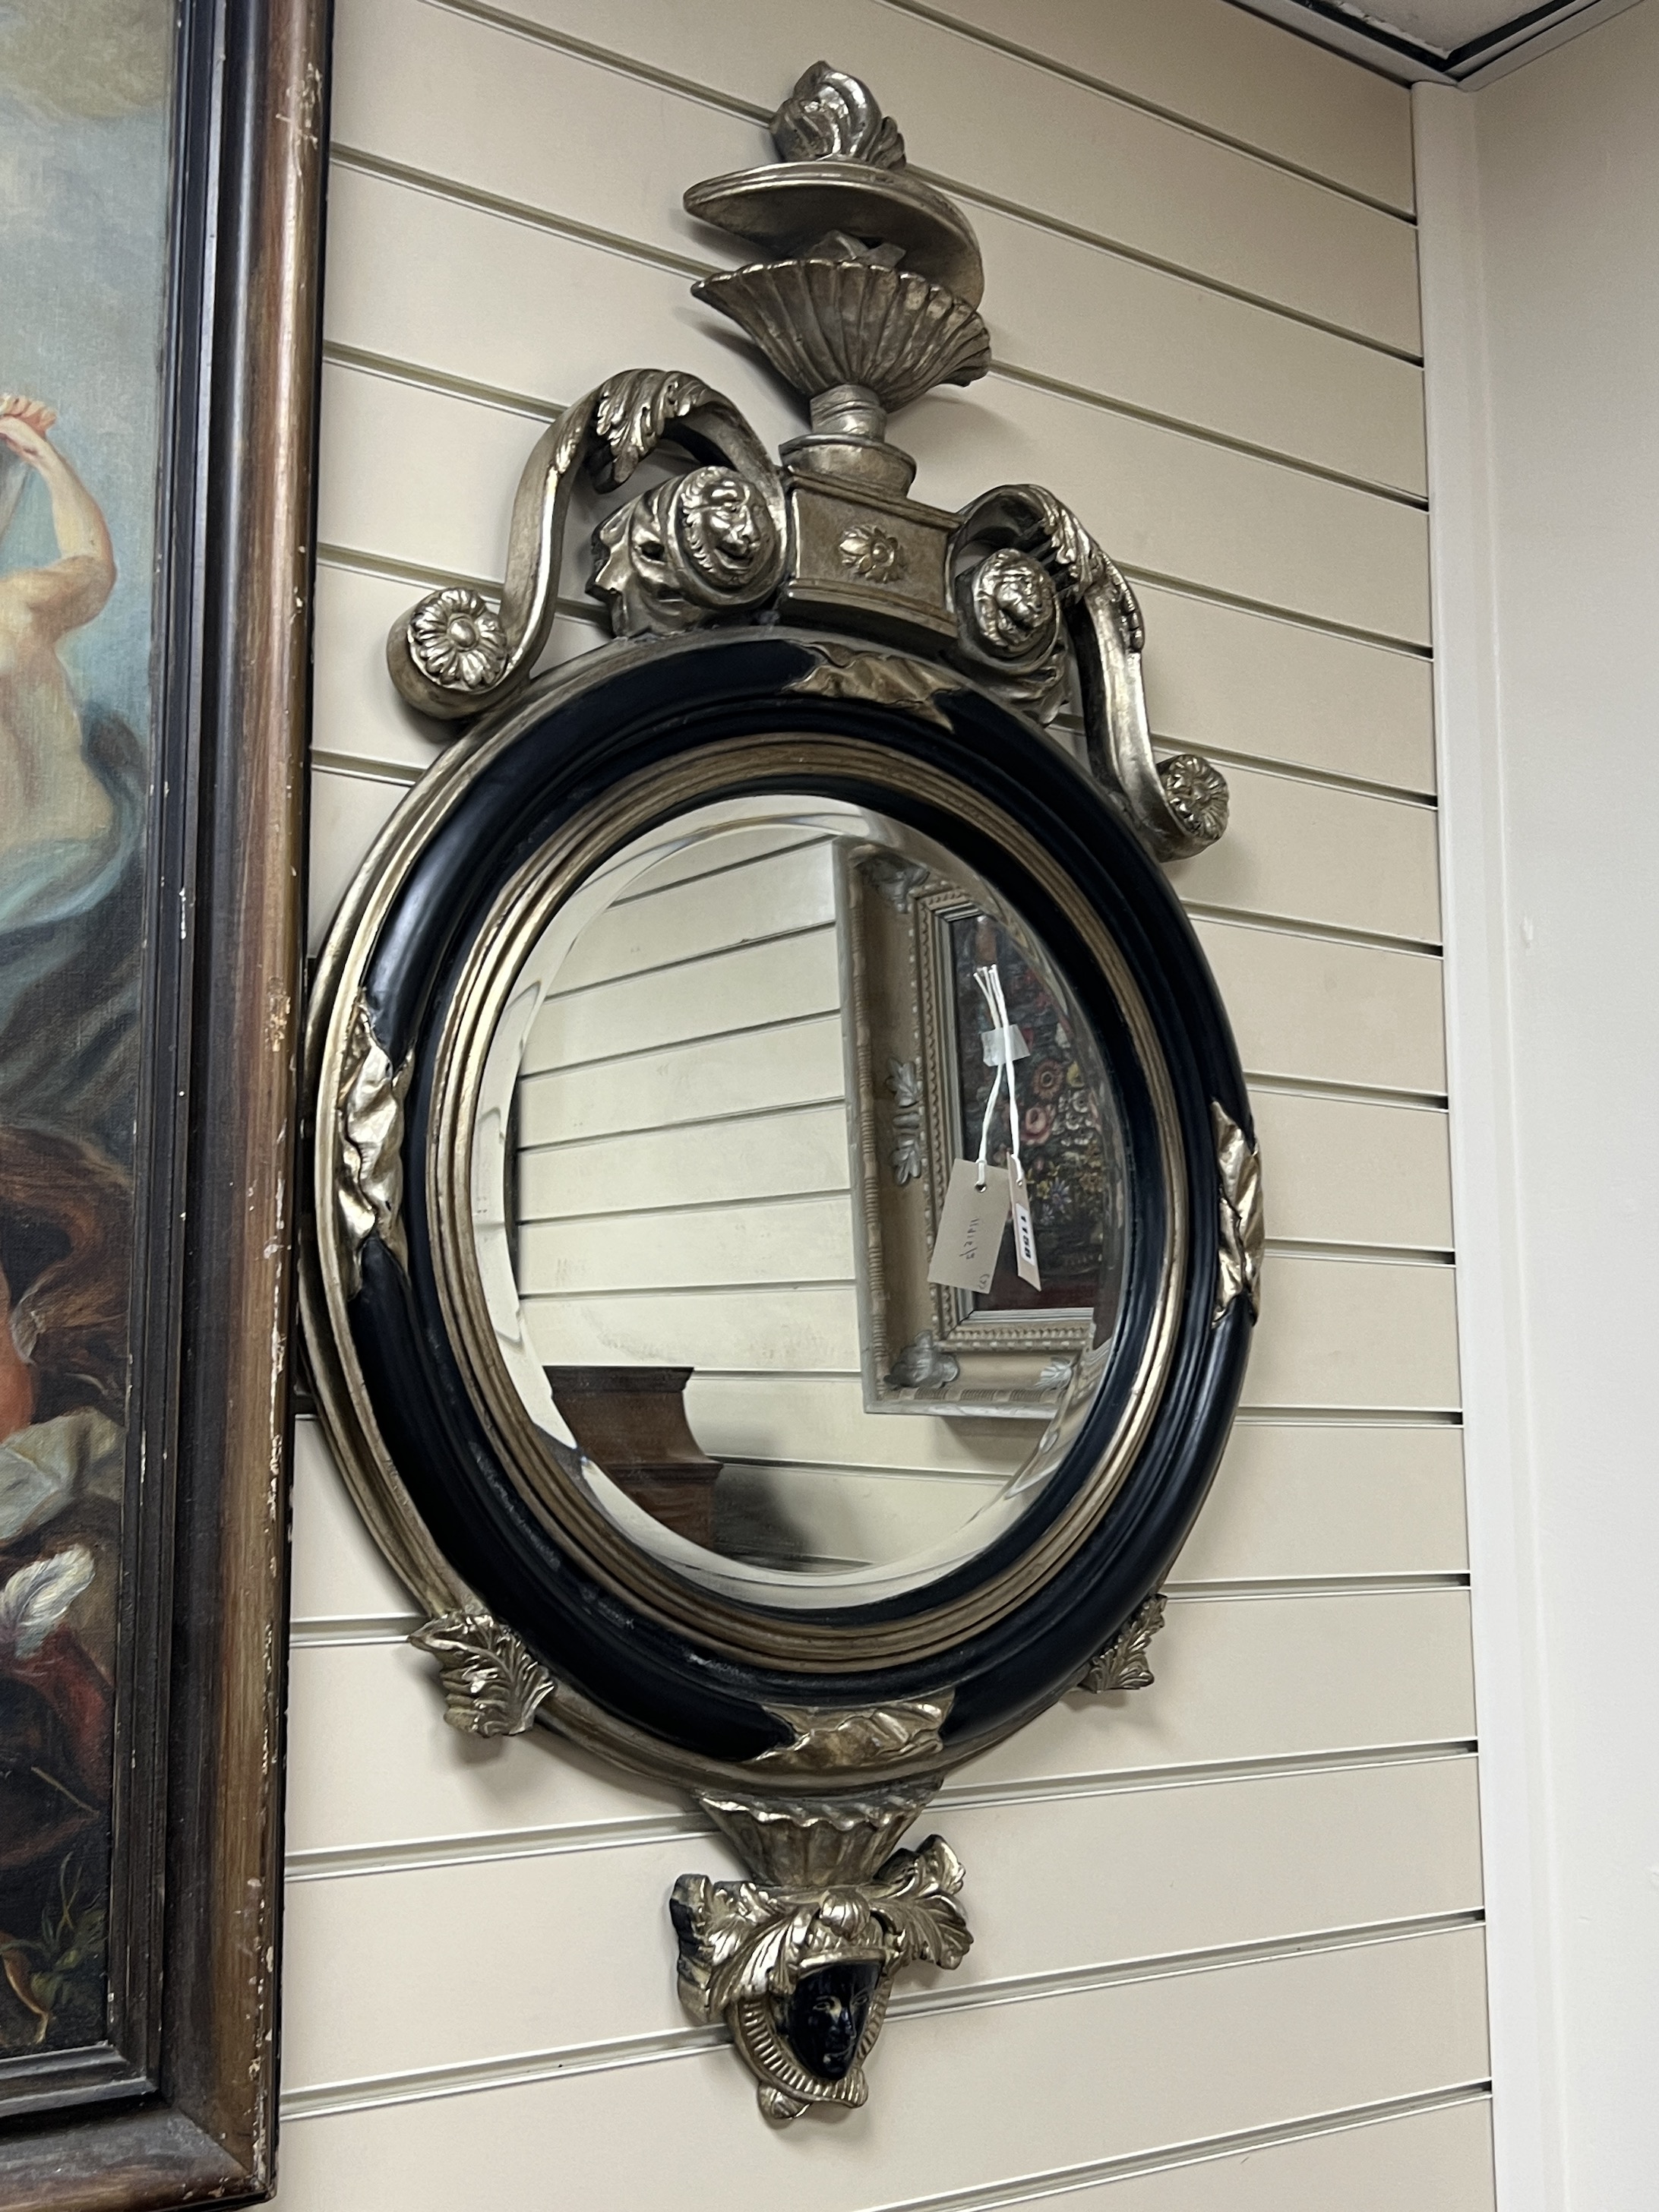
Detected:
[{"left": 836, "top": 852, "right": 1126, "bottom": 1420}]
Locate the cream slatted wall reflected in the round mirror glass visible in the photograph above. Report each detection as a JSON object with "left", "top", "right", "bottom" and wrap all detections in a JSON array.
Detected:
[{"left": 517, "top": 827, "right": 1035, "bottom": 1562}]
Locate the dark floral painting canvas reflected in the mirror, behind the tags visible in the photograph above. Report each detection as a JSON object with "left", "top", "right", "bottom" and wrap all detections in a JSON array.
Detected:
[{"left": 949, "top": 914, "right": 1111, "bottom": 1310}]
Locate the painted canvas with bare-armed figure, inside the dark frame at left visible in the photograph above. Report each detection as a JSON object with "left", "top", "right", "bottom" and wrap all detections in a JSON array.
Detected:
[{"left": 0, "top": 13, "right": 172, "bottom": 2055}]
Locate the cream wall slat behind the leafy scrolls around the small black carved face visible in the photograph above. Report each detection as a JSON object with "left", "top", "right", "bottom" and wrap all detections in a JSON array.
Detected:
[{"left": 283, "top": 1756, "right": 1480, "bottom": 2095}]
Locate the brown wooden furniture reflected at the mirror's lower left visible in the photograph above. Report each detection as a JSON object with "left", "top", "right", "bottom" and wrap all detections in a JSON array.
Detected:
[{"left": 546, "top": 1367, "right": 723, "bottom": 1546}]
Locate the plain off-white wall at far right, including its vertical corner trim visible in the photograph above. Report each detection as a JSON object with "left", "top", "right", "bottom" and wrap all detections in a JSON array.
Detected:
[{"left": 1418, "top": 0, "right": 1659, "bottom": 2212}]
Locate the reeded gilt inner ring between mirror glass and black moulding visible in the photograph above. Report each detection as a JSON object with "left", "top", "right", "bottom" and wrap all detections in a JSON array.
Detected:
[{"left": 425, "top": 730, "right": 1188, "bottom": 1672}]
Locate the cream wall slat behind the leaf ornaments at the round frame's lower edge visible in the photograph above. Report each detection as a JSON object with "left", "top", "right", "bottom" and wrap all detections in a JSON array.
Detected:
[{"left": 288, "top": 1588, "right": 1473, "bottom": 1856}]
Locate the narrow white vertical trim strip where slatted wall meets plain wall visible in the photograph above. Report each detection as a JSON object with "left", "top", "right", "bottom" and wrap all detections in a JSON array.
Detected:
[{"left": 1411, "top": 84, "right": 1566, "bottom": 2212}]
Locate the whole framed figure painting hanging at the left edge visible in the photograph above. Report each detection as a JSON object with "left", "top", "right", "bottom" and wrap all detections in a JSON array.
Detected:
[{"left": 0, "top": 0, "right": 327, "bottom": 2205}]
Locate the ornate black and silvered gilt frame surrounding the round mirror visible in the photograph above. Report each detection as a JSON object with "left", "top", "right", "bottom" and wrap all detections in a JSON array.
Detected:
[{"left": 303, "top": 62, "right": 1263, "bottom": 2122}]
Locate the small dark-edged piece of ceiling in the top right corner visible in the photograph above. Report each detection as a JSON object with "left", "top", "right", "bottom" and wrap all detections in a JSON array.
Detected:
[{"left": 1237, "top": 0, "right": 1635, "bottom": 84}]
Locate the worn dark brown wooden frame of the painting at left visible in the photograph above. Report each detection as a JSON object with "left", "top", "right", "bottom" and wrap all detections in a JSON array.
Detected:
[{"left": 0, "top": 0, "right": 327, "bottom": 2212}]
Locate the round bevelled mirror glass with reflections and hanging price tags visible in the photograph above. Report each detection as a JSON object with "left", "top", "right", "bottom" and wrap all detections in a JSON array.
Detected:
[{"left": 471, "top": 792, "right": 1126, "bottom": 1608}]
